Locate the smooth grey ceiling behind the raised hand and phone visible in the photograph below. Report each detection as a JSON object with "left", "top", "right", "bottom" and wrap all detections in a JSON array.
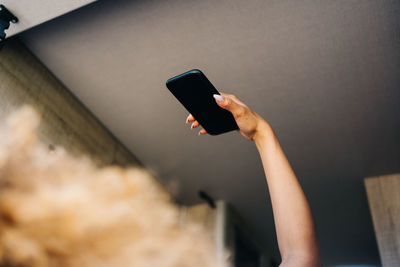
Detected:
[{"left": 22, "top": 0, "right": 400, "bottom": 265}]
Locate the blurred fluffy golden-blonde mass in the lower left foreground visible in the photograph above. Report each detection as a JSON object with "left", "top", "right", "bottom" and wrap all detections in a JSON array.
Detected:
[{"left": 0, "top": 107, "right": 217, "bottom": 267}]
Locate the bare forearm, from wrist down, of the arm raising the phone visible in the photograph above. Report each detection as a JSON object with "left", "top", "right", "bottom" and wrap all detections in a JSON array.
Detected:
[{"left": 254, "top": 121, "right": 320, "bottom": 266}]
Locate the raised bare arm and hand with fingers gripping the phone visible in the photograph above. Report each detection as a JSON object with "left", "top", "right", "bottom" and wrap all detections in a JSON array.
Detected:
[{"left": 186, "top": 93, "right": 322, "bottom": 267}]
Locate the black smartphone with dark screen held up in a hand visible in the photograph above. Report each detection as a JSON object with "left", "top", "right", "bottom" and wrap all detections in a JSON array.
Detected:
[{"left": 167, "top": 69, "right": 239, "bottom": 135}]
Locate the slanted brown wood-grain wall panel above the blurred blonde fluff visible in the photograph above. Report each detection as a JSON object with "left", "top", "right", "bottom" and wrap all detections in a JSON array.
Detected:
[{"left": 0, "top": 38, "right": 140, "bottom": 168}]
